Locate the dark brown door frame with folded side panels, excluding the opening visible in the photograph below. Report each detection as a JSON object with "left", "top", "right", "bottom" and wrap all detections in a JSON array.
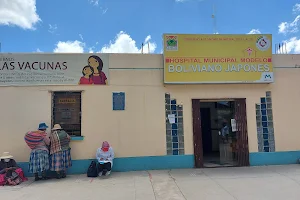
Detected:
[{"left": 192, "top": 98, "right": 249, "bottom": 168}]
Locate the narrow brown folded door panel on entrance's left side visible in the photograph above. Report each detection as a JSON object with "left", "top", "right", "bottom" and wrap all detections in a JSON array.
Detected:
[{"left": 192, "top": 99, "right": 203, "bottom": 168}]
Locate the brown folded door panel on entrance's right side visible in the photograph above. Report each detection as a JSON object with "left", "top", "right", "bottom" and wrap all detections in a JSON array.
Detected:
[{"left": 235, "top": 99, "right": 249, "bottom": 166}]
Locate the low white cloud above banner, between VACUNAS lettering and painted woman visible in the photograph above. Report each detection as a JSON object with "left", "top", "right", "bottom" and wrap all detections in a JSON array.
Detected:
[{"left": 53, "top": 40, "right": 85, "bottom": 53}]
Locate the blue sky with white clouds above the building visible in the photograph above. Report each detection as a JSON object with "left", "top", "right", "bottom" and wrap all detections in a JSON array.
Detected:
[{"left": 0, "top": 0, "right": 300, "bottom": 53}]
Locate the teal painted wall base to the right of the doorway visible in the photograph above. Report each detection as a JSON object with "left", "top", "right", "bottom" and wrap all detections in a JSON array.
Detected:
[{"left": 249, "top": 151, "right": 300, "bottom": 166}]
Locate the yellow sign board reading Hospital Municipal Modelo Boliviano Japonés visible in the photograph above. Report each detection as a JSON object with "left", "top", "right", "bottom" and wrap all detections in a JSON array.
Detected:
[{"left": 163, "top": 34, "right": 274, "bottom": 84}]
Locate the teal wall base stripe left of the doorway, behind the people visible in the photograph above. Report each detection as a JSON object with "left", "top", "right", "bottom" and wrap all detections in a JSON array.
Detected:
[{"left": 18, "top": 155, "right": 194, "bottom": 176}]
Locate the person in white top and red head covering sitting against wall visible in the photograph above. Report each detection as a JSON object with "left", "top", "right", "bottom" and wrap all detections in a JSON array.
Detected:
[{"left": 96, "top": 141, "right": 115, "bottom": 176}]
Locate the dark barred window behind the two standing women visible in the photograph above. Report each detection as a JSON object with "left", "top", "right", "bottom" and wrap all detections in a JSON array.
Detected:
[{"left": 52, "top": 91, "right": 81, "bottom": 136}]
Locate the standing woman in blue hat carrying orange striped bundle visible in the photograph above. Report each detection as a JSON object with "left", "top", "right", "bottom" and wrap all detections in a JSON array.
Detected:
[{"left": 25, "top": 123, "right": 50, "bottom": 181}]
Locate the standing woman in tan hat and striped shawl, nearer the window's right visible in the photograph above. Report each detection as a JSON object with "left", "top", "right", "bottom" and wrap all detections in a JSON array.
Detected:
[{"left": 50, "top": 124, "right": 72, "bottom": 179}]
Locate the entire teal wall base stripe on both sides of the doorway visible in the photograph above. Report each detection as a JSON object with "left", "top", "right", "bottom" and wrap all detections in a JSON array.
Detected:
[{"left": 18, "top": 151, "right": 300, "bottom": 176}]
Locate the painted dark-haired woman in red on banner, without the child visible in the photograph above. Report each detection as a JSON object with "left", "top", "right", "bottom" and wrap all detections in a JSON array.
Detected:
[{"left": 88, "top": 55, "right": 107, "bottom": 85}]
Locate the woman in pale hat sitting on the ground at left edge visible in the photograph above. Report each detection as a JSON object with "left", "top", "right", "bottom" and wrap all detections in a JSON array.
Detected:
[{"left": 0, "top": 152, "right": 26, "bottom": 186}]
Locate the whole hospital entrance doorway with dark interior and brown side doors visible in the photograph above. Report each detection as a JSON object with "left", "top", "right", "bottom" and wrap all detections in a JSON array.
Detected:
[{"left": 192, "top": 99, "right": 249, "bottom": 167}]
